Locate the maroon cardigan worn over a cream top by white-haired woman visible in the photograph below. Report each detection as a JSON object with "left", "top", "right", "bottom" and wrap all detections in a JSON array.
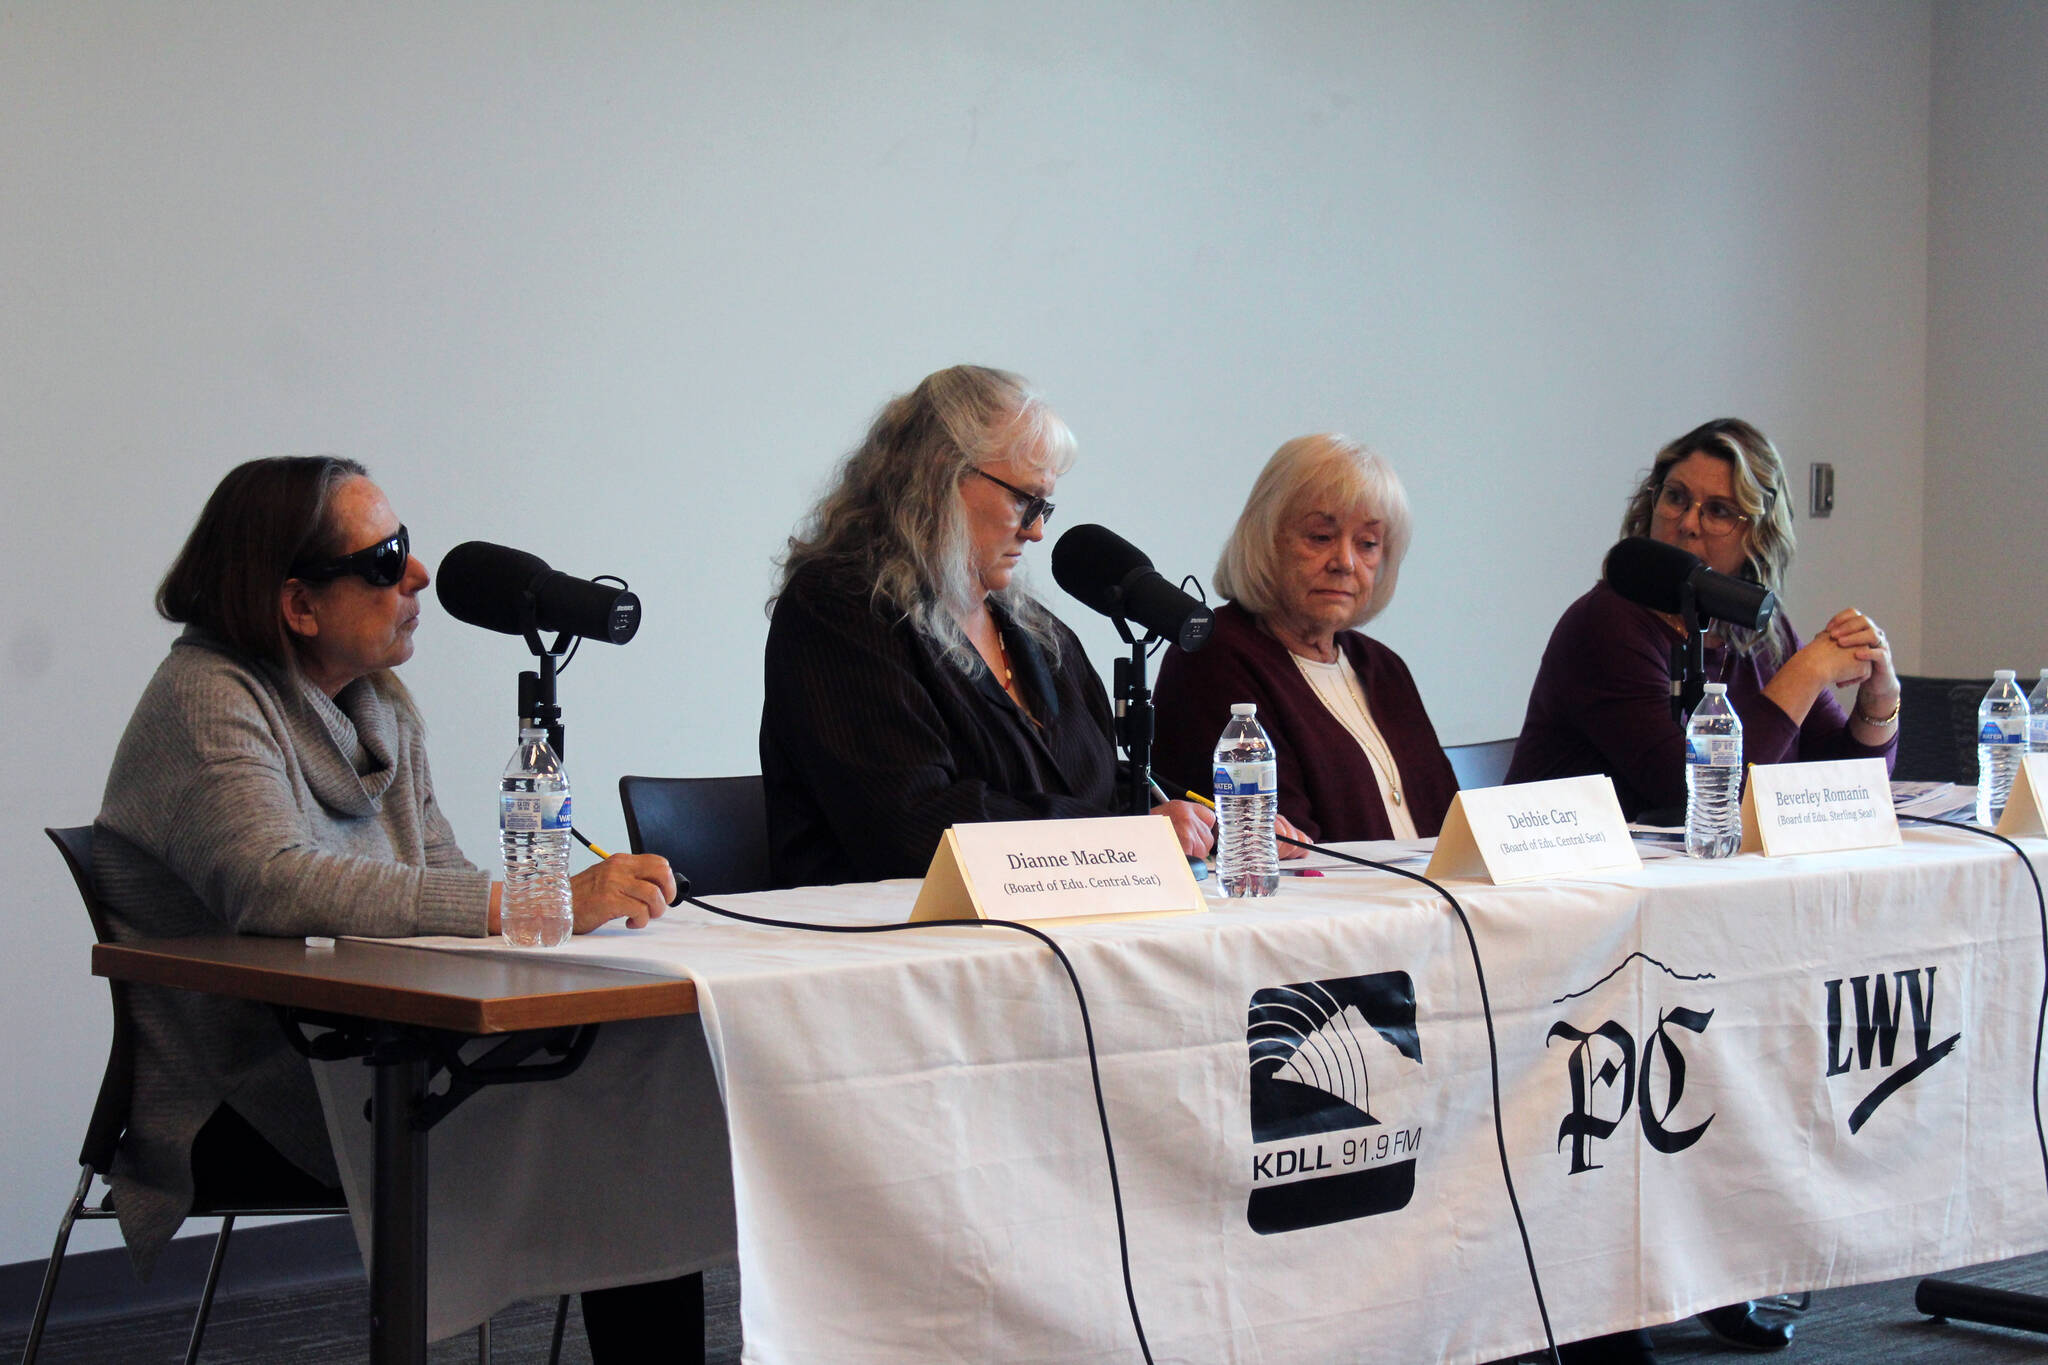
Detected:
[{"left": 1153, "top": 602, "right": 1458, "bottom": 843}]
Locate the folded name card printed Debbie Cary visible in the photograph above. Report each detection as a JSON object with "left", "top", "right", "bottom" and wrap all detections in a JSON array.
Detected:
[{"left": 1430, "top": 776, "right": 1642, "bottom": 884}]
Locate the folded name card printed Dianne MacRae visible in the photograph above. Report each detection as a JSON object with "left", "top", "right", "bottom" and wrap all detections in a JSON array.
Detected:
[{"left": 909, "top": 814, "right": 1208, "bottom": 921}]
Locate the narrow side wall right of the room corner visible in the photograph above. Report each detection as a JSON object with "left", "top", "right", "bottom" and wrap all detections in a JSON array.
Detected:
[{"left": 1925, "top": 0, "right": 2048, "bottom": 686}]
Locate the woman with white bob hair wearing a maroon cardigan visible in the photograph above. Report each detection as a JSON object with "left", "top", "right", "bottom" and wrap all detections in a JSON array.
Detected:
[{"left": 1155, "top": 434, "right": 1458, "bottom": 843}]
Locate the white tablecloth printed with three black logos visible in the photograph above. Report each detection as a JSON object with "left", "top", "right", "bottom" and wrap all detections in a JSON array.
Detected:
[{"left": 339, "top": 831, "right": 2048, "bottom": 1365}]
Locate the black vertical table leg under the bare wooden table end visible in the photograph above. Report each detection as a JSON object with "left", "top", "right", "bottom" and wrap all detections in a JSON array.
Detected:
[{"left": 371, "top": 1025, "right": 428, "bottom": 1365}]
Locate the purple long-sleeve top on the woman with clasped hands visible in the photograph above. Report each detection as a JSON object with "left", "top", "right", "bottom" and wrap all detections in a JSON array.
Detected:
[{"left": 1507, "top": 583, "right": 1898, "bottom": 819}]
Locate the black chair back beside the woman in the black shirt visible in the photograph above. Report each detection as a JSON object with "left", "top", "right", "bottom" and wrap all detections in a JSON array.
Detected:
[{"left": 618, "top": 776, "right": 774, "bottom": 896}]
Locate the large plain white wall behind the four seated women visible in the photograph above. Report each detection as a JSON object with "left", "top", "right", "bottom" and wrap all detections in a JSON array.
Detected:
[{"left": 0, "top": 0, "right": 1929, "bottom": 1263}]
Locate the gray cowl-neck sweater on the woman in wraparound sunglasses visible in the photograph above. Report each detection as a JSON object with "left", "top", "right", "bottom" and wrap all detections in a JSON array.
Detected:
[{"left": 92, "top": 628, "right": 489, "bottom": 1275}]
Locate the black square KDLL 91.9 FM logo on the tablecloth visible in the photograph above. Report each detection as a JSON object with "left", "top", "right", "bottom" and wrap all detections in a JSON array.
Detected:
[{"left": 1245, "top": 972, "right": 1421, "bottom": 1234}]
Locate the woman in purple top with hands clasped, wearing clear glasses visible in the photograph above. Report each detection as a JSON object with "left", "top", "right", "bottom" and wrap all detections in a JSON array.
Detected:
[{"left": 1507, "top": 417, "right": 1898, "bottom": 821}]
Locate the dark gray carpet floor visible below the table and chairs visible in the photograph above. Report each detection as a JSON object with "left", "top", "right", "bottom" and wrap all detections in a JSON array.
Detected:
[{"left": 12, "top": 1252, "right": 2048, "bottom": 1365}]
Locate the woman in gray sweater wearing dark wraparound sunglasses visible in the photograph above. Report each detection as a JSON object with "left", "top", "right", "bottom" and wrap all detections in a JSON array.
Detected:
[{"left": 92, "top": 456, "right": 702, "bottom": 1361}]
